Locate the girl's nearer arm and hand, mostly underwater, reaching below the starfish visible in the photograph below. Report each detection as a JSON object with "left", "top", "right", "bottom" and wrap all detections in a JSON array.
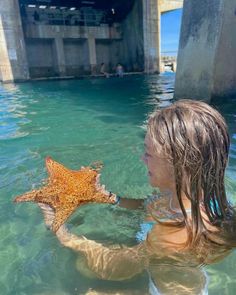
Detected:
[{"left": 39, "top": 204, "right": 148, "bottom": 281}]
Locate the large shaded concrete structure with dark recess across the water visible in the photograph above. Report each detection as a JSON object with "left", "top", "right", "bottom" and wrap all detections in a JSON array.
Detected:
[{"left": 0, "top": 0, "right": 183, "bottom": 82}]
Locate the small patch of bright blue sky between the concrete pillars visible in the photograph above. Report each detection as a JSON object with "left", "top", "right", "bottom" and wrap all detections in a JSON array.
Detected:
[{"left": 161, "top": 9, "right": 183, "bottom": 55}]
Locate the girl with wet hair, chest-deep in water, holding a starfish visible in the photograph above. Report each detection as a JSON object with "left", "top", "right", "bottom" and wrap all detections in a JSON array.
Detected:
[{"left": 39, "top": 100, "right": 236, "bottom": 294}]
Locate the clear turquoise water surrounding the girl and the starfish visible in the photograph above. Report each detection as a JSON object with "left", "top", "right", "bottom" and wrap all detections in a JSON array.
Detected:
[{"left": 0, "top": 74, "right": 236, "bottom": 295}]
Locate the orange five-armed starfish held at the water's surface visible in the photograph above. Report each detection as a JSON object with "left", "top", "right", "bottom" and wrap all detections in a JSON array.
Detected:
[{"left": 14, "top": 157, "right": 116, "bottom": 232}]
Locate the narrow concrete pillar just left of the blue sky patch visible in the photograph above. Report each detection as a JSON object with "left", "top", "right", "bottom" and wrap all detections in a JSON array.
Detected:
[{"left": 143, "top": 0, "right": 161, "bottom": 73}]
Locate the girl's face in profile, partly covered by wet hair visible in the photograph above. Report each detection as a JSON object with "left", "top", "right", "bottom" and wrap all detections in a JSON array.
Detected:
[{"left": 142, "top": 133, "right": 175, "bottom": 190}]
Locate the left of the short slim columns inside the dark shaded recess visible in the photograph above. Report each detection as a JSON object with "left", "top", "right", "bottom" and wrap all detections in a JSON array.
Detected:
[{"left": 54, "top": 37, "right": 66, "bottom": 76}]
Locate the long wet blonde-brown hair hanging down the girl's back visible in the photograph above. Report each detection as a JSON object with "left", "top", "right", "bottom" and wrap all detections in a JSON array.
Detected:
[{"left": 148, "top": 100, "right": 236, "bottom": 256}]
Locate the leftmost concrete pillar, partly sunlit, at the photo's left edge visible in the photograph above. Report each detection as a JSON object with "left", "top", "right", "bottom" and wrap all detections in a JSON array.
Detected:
[{"left": 0, "top": 0, "right": 29, "bottom": 82}]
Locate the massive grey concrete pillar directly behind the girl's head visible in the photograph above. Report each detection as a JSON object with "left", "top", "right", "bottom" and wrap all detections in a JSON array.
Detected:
[{"left": 175, "top": 0, "right": 236, "bottom": 101}]
